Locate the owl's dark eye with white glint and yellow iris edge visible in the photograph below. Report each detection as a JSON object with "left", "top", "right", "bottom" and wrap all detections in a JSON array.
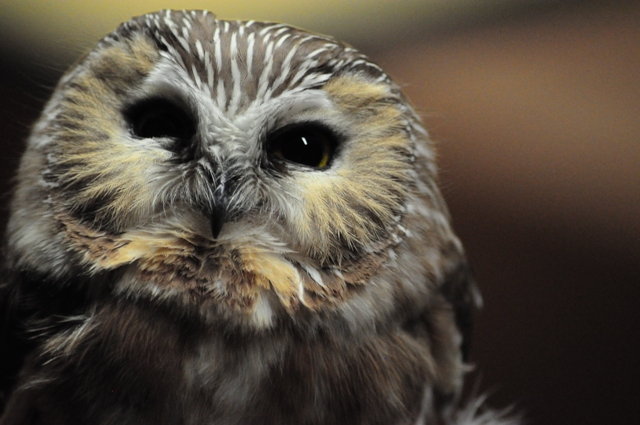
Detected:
[{"left": 267, "top": 123, "right": 338, "bottom": 168}]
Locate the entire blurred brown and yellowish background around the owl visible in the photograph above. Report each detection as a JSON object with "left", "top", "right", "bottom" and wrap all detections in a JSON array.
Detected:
[{"left": 0, "top": 0, "right": 640, "bottom": 425}]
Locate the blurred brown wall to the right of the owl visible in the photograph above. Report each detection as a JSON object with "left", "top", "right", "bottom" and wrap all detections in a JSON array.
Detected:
[{"left": 374, "top": 3, "right": 640, "bottom": 424}]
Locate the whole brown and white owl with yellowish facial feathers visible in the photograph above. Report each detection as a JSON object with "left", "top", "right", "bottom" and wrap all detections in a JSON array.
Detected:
[{"left": 0, "top": 11, "right": 506, "bottom": 425}]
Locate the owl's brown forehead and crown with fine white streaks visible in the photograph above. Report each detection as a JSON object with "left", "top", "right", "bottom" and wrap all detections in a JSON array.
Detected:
[{"left": 111, "top": 11, "right": 388, "bottom": 115}]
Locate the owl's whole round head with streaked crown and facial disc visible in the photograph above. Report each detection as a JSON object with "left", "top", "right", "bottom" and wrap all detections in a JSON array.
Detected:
[{"left": 9, "top": 11, "right": 462, "bottom": 329}]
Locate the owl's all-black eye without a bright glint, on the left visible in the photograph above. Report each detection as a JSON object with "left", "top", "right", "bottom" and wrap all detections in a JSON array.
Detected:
[{"left": 126, "top": 99, "right": 196, "bottom": 141}]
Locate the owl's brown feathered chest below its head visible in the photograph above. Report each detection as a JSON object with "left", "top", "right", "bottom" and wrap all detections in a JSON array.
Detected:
[{"left": 21, "top": 302, "right": 430, "bottom": 425}]
